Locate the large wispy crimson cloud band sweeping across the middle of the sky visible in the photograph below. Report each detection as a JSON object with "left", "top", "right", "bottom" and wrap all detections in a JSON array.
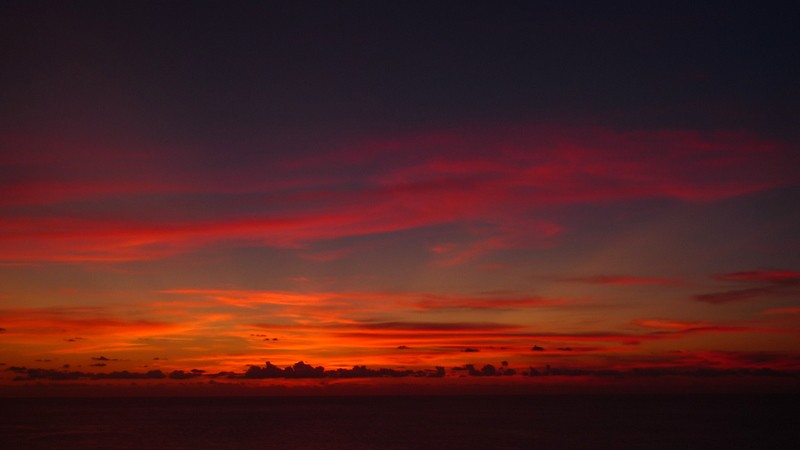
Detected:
[{"left": 0, "top": 124, "right": 797, "bottom": 266}]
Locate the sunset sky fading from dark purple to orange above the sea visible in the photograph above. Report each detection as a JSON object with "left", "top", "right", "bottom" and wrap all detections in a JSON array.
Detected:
[{"left": 0, "top": 1, "right": 800, "bottom": 387}]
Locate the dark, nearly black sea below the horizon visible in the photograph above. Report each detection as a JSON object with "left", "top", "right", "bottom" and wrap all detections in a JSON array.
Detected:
[{"left": 0, "top": 395, "right": 800, "bottom": 450}]
